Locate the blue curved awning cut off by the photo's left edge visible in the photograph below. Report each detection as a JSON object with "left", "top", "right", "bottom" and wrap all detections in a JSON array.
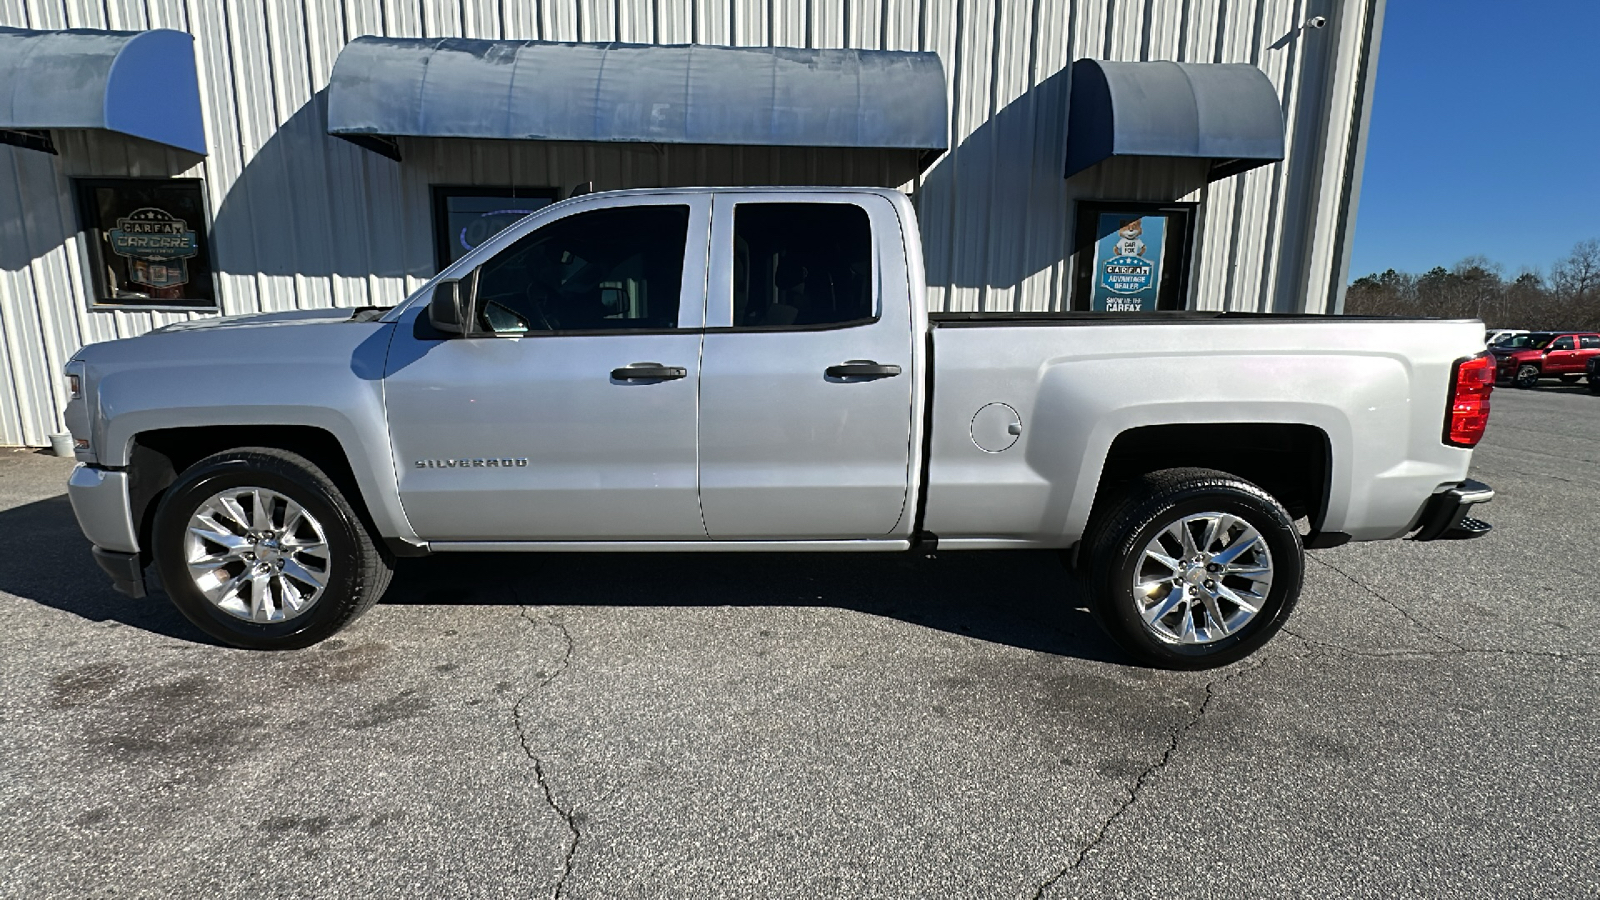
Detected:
[{"left": 0, "top": 29, "right": 205, "bottom": 155}]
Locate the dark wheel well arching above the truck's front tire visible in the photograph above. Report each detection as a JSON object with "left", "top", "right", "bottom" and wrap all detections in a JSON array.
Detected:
[{"left": 128, "top": 424, "right": 378, "bottom": 562}]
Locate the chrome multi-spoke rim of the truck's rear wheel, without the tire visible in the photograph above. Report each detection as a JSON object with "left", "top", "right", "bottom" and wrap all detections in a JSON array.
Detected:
[{"left": 1133, "top": 512, "right": 1272, "bottom": 644}]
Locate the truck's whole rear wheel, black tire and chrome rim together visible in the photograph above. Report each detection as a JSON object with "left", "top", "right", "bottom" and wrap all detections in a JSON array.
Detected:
[{"left": 1083, "top": 469, "right": 1306, "bottom": 669}]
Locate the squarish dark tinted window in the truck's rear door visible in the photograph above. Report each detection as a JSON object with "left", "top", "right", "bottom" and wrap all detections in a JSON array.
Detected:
[{"left": 733, "top": 203, "right": 874, "bottom": 328}]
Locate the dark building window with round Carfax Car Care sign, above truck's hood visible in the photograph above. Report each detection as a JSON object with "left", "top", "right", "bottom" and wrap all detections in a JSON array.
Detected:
[{"left": 74, "top": 178, "right": 216, "bottom": 309}]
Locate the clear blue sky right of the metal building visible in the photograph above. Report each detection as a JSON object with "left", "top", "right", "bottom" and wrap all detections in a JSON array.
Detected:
[{"left": 1350, "top": 0, "right": 1600, "bottom": 279}]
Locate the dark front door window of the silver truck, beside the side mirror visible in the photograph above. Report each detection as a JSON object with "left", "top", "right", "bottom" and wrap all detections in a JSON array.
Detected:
[{"left": 477, "top": 205, "right": 690, "bottom": 335}]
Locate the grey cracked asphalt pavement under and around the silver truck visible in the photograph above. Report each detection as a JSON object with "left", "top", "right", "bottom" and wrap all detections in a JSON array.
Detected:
[{"left": 0, "top": 386, "right": 1600, "bottom": 900}]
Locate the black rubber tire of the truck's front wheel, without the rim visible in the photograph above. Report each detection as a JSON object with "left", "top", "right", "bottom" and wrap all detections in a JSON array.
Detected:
[{"left": 154, "top": 447, "right": 394, "bottom": 650}]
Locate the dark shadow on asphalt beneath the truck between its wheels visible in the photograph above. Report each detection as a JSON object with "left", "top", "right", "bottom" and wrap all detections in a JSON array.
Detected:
[{"left": 382, "top": 551, "right": 1133, "bottom": 665}]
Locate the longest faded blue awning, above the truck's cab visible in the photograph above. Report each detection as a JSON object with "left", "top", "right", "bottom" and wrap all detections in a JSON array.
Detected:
[{"left": 328, "top": 37, "right": 949, "bottom": 159}]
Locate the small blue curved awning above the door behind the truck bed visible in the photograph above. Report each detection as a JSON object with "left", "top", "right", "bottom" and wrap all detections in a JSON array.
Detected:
[{"left": 1067, "top": 59, "right": 1283, "bottom": 181}]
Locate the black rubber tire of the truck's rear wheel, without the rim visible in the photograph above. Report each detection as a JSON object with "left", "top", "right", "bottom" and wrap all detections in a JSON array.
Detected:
[{"left": 1080, "top": 469, "right": 1306, "bottom": 669}]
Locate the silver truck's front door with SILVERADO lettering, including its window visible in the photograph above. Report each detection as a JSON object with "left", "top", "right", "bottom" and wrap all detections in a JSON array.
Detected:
[{"left": 386, "top": 194, "right": 710, "bottom": 541}]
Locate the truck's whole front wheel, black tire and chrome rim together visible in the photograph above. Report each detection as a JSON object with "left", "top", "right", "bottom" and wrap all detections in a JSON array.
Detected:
[{"left": 154, "top": 447, "right": 392, "bottom": 650}]
